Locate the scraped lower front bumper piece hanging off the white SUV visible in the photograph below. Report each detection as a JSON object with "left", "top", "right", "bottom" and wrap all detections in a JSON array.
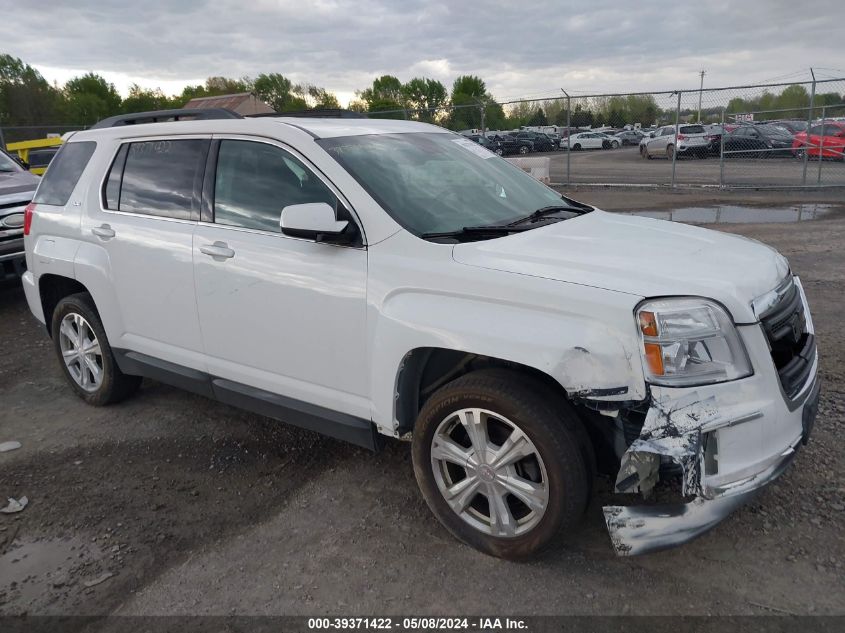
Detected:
[{"left": 604, "top": 436, "right": 799, "bottom": 556}]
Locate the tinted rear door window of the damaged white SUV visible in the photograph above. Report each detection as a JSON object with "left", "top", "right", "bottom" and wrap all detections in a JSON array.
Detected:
[{"left": 117, "top": 139, "right": 208, "bottom": 220}]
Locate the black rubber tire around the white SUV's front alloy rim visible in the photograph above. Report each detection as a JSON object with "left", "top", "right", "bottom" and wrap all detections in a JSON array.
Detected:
[{"left": 412, "top": 376, "right": 587, "bottom": 560}]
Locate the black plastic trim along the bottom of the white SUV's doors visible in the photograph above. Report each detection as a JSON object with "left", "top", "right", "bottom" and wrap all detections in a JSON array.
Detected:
[{"left": 112, "top": 348, "right": 382, "bottom": 451}]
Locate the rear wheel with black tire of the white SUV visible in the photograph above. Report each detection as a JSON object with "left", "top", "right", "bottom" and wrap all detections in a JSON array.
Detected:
[{"left": 50, "top": 292, "right": 141, "bottom": 407}]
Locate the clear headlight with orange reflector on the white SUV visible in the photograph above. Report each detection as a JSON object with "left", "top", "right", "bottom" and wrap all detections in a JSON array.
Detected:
[{"left": 637, "top": 298, "right": 752, "bottom": 387}]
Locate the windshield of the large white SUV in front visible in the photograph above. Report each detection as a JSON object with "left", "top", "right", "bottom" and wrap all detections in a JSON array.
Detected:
[{"left": 317, "top": 132, "right": 567, "bottom": 235}]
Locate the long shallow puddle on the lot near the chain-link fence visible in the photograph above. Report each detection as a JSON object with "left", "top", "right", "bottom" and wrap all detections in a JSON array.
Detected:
[{"left": 623, "top": 204, "right": 841, "bottom": 224}]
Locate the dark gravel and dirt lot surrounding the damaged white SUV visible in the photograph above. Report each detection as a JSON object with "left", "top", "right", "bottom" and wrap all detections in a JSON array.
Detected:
[{"left": 0, "top": 190, "right": 845, "bottom": 627}]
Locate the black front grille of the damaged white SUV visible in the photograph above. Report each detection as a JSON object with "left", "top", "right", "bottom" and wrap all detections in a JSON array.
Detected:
[{"left": 760, "top": 284, "right": 816, "bottom": 398}]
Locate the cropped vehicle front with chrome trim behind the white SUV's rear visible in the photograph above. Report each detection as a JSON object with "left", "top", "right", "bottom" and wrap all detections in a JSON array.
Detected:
[{"left": 0, "top": 149, "right": 40, "bottom": 280}]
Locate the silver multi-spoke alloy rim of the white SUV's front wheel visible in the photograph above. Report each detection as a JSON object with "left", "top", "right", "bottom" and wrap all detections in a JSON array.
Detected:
[{"left": 431, "top": 408, "right": 549, "bottom": 538}]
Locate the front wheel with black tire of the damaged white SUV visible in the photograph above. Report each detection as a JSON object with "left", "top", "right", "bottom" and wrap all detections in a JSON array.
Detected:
[{"left": 412, "top": 370, "right": 592, "bottom": 560}]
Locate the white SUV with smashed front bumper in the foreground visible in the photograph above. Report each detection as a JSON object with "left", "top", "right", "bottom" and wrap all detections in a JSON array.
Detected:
[{"left": 23, "top": 113, "right": 818, "bottom": 558}]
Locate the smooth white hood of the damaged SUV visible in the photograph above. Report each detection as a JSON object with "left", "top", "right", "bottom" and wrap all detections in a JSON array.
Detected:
[{"left": 453, "top": 210, "right": 789, "bottom": 323}]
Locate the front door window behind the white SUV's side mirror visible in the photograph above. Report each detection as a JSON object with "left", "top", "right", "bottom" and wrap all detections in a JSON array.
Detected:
[{"left": 214, "top": 140, "right": 337, "bottom": 232}]
